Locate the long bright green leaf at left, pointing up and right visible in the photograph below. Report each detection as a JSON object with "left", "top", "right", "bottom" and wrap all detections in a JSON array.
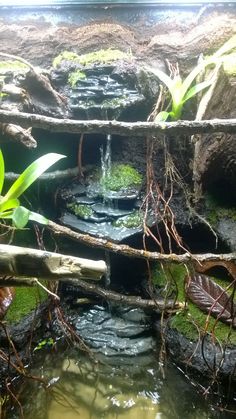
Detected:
[{"left": 3, "top": 153, "right": 65, "bottom": 200}]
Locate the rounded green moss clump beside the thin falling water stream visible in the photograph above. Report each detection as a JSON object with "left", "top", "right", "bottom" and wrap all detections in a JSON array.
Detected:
[{"left": 101, "top": 164, "right": 142, "bottom": 191}]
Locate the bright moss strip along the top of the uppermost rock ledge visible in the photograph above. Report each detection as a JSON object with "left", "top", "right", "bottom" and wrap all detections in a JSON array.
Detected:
[{"left": 53, "top": 48, "right": 130, "bottom": 67}]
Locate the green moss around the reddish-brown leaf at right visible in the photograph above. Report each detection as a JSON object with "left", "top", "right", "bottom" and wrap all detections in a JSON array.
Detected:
[{"left": 152, "top": 264, "right": 236, "bottom": 344}]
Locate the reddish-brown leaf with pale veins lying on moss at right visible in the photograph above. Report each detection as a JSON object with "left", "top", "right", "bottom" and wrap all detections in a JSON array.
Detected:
[{"left": 186, "top": 274, "right": 236, "bottom": 327}]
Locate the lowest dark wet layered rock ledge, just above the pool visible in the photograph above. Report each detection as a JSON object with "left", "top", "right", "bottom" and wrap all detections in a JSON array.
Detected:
[{"left": 67, "top": 306, "right": 156, "bottom": 358}]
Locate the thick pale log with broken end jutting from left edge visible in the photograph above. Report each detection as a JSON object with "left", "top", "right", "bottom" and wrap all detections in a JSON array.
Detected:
[{"left": 0, "top": 244, "right": 106, "bottom": 281}]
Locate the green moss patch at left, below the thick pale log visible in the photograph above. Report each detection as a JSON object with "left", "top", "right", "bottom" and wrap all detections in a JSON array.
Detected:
[{"left": 4, "top": 287, "right": 48, "bottom": 323}]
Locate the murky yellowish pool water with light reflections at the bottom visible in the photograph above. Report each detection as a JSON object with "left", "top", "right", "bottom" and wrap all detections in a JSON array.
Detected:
[{"left": 8, "top": 349, "right": 216, "bottom": 419}]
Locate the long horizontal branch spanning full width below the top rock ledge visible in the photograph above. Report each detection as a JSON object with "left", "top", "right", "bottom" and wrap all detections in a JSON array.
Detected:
[{"left": 0, "top": 110, "right": 236, "bottom": 137}]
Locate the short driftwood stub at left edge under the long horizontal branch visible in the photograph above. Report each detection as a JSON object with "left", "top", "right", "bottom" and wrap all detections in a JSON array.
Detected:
[{"left": 0, "top": 123, "right": 37, "bottom": 148}]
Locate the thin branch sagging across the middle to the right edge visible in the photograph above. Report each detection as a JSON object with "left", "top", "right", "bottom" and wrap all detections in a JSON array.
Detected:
[{"left": 47, "top": 221, "right": 236, "bottom": 272}]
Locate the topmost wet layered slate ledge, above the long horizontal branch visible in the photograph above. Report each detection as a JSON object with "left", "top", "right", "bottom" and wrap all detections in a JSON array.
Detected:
[{"left": 51, "top": 60, "right": 156, "bottom": 120}]
